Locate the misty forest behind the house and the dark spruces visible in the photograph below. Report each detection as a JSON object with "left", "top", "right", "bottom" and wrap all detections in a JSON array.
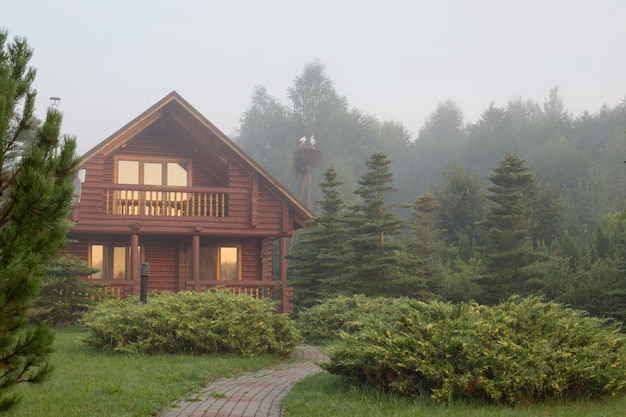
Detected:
[{"left": 235, "top": 62, "right": 626, "bottom": 319}]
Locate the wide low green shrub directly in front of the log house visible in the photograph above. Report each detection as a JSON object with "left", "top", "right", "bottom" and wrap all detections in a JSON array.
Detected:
[{"left": 82, "top": 290, "right": 301, "bottom": 356}]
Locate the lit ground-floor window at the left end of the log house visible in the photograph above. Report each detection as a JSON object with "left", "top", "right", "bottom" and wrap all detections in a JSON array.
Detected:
[{"left": 89, "top": 244, "right": 141, "bottom": 280}]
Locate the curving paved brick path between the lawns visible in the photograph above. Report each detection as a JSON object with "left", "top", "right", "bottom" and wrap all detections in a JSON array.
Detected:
[{"left": 159, "top": 346, "right": 328, "bottom": 417}]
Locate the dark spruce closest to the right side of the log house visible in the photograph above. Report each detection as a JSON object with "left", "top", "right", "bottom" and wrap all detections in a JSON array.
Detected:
[{"left": 288, "top": 167, "right": 347, "bottom": 309}]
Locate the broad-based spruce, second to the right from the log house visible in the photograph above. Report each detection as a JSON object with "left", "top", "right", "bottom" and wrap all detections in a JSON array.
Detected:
[{"left": 343, "top": 152, "right": 425, "bottom": 296}]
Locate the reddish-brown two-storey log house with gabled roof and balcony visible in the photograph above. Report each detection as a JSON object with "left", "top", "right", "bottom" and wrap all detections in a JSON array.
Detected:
[{"left": 65, "top": 92, "right": 313, "bottom": 312}]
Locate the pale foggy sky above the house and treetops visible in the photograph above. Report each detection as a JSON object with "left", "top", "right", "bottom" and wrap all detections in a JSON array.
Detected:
[{"left": 0, "top": 0, "right": 626, "bottom": 154}]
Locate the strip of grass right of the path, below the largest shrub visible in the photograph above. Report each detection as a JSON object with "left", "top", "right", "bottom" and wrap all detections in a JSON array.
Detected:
[{"left": 283, "top": 372, "right": 626, "bottom": 417}]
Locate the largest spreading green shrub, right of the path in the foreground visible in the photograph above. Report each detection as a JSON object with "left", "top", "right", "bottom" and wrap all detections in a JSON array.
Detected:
[{"left": 324, "top": 298, "right": 626, "bottom": 404}]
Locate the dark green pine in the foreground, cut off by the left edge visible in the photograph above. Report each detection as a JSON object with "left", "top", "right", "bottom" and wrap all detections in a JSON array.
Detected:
[{"left": 0, "top": 31, "right": 78, "bottom": 411}]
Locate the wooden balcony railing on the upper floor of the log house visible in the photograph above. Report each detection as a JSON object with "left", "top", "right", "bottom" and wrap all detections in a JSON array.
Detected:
[{"left": 105, "top": 185, "right": 228, "bottom": 217}]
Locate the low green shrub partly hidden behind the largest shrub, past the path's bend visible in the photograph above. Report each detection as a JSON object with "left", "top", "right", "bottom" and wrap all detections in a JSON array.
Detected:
[{"left": 298, "top": 295, "right": 405, "bottom": 341}]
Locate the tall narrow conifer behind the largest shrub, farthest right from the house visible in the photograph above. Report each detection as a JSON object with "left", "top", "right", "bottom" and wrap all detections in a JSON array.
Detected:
[{"left": 481, "top": 153, "right": 538, "bottom": 302}]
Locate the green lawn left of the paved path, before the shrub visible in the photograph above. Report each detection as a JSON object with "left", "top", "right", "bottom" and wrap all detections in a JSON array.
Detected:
[{"left": 8, "top": 329, "right": 280, "bottom": 417}]
